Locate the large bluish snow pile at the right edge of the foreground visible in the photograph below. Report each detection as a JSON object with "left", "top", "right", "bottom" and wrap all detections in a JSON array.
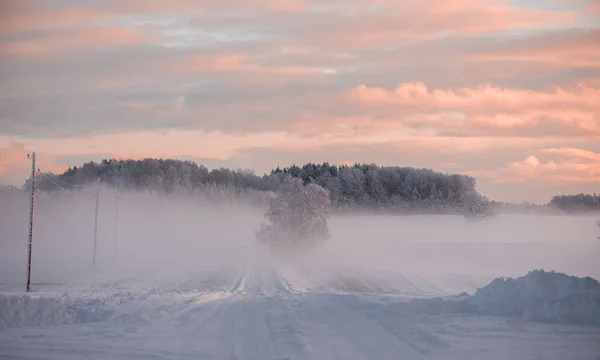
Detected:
[{"left": 464, "top": 270, "right": 600, "bottom": 325}]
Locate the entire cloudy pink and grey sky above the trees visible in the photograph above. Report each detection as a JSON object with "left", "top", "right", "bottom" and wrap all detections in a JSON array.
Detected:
[{"left": 0, "top": 0, "right": 600, "bottom": 203}]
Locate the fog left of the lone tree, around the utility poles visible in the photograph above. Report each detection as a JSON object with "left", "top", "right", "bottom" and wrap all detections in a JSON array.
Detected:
[{"left": 0, "top": 190, "right": 262, "bottom": 282}]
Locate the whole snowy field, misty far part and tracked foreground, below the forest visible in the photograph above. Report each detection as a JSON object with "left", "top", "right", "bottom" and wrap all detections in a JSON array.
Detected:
[{"left": 0, "top": 195, "right": 600, "bottom": 360}]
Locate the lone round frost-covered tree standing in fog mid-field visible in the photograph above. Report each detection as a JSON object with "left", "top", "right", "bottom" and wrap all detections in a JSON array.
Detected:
[{"left": 256, "top": 177, "right": 331, "bottom": 249}]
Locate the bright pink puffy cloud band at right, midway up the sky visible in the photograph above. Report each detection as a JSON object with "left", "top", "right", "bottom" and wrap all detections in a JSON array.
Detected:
[{"left": 338, "top": 82, "right": 600, "bottom": 137}]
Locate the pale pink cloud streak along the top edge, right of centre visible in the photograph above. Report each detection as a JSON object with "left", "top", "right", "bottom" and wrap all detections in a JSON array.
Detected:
[{"left": 276, "top": 1, "right": 577, "bottom": 51}]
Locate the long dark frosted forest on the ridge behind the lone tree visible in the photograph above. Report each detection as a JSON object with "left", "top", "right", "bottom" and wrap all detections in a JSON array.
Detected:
[{"left": 25, "top": 159, "right": 476, "bottom": 212}]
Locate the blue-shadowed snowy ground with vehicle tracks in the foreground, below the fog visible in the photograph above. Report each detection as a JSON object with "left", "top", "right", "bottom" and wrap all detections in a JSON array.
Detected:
[{"left": 0, "top": 262, "right": 600, "bottom": 360}]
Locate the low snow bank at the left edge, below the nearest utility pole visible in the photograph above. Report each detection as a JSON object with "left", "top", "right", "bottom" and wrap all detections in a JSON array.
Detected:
[{"left": 0, "top": 295, "right": 110, "bottom": 330}]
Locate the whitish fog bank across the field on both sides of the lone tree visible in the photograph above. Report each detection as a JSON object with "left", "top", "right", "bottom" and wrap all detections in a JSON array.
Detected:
[{"left": 0, "top": 189, "right": 600, "bottom": 291}]
